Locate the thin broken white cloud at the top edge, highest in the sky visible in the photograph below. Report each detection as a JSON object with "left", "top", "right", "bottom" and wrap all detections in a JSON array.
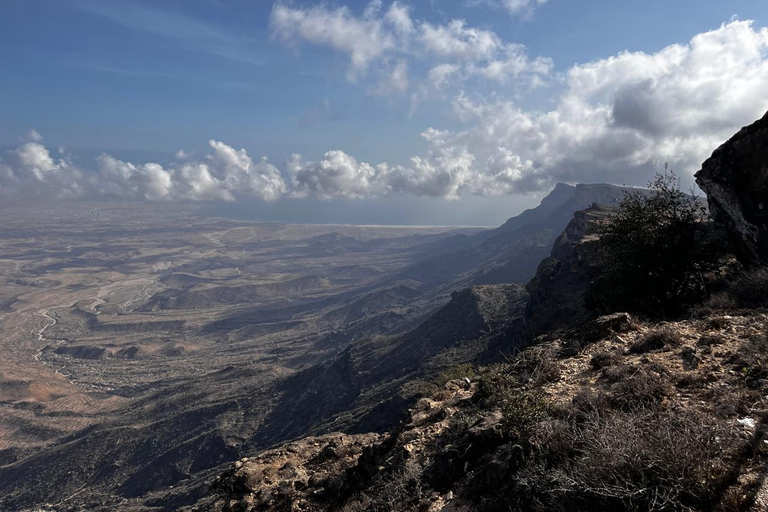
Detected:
[{"left": 270, "top": 0, "right": 552, "bottom": 94}]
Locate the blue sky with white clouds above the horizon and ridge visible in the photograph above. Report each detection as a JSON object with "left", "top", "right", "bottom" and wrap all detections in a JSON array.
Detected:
[{"left": 0, "top": 0, "right": 768, "bottom": 226}]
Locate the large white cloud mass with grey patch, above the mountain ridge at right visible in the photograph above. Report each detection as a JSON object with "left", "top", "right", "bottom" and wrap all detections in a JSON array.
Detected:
[{"left": 284, "top": 21, "right": 768, "bottom": 199}]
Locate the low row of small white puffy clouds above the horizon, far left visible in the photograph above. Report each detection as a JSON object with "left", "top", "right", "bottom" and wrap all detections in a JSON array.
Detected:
[{"left": 0, "top": 136, "right": 286, "bottom": 201}]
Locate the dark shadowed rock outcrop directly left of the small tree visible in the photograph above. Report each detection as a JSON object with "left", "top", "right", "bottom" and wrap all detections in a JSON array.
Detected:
[{"left": 520, "top": 204, "right": 610, "bottom": 345}]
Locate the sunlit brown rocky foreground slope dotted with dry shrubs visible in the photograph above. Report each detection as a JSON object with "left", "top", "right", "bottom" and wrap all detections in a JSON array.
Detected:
[{"left": 195, "top": 313, "right": 768, "bottom": 512}]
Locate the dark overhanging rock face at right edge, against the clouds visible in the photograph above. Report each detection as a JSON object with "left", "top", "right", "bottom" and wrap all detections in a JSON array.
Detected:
[{"left": 696, "top": 110, "right": 768, "bottom": 265}]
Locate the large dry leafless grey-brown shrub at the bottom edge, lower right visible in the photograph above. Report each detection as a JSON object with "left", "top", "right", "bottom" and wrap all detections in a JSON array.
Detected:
[{"left": 520, "top": 410, "right": 739, "bottom": 510}]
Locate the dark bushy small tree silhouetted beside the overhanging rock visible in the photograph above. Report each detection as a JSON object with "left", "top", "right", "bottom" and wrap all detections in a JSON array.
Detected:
[{"left": 587, "top": 168, "right": 723, "bottom": 317}]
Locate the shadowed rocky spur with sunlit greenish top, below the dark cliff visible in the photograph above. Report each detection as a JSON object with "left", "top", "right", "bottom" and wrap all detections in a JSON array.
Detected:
[{"left": 254, "top": 284, "right": 526, "bottom": 446}]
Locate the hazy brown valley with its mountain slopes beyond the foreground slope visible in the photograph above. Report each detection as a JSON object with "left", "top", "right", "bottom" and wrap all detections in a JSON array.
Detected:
[{"left": 0, "top": 185, "right": 621, "bottom": 510}]
